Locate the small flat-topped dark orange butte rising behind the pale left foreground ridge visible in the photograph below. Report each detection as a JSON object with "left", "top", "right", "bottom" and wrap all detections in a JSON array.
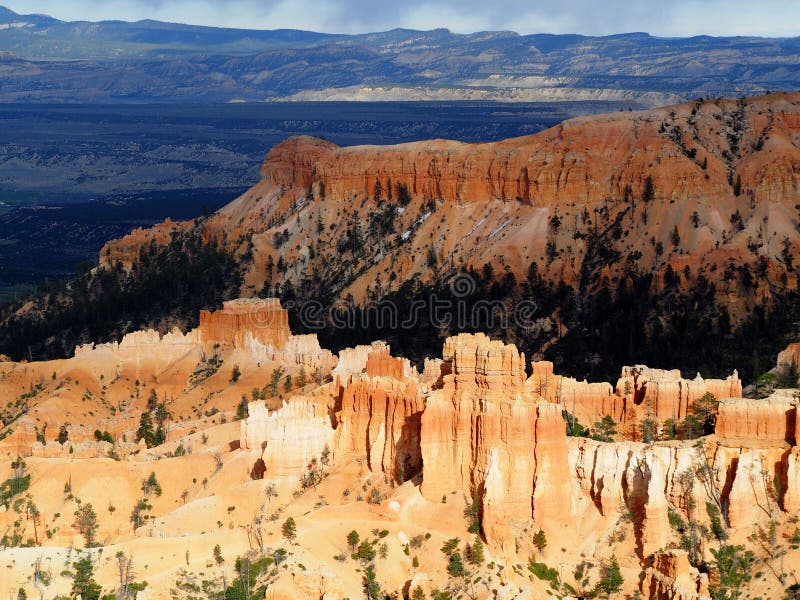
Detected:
[{"left": 199, "top": 298, "right": 292, "bottom": 349}]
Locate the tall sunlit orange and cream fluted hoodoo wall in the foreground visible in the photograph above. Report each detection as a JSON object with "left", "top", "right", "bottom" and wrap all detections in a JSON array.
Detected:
[{"left": 241, "top": 334, "right": 800, "bottom": 556}]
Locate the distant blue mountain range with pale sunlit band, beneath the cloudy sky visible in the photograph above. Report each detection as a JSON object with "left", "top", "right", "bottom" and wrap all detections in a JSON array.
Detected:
[{"left": 0, "top": 7, "right": 800, "bottom": 105}]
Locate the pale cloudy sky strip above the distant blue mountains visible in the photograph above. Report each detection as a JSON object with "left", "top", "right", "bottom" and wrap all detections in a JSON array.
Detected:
[{"left": 6, "top": 0, "right": 800, "bottom": 37}]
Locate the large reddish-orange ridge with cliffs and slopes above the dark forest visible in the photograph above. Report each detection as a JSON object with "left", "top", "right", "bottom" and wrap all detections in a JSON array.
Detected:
[{"left": 100, "top": 94, "right": 800, "bottom": 338}]
